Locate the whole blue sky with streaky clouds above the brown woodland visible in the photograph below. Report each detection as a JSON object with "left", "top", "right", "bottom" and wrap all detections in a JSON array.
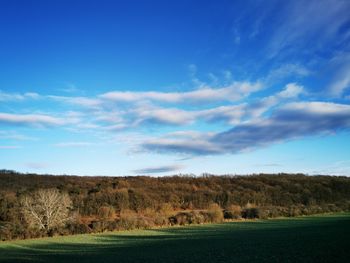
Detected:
[{"left": 0, "top": 0, "right": 350, "bottom": 176}]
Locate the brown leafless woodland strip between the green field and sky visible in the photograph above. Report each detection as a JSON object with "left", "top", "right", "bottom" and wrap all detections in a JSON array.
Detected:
[{"left": 0, "top": 170, "right": 350, "bottom": 240}]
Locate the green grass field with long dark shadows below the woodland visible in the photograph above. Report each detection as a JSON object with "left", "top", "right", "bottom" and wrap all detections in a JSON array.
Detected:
[{"left": 0, "top": 213, "right": 350, "bottom": 263}]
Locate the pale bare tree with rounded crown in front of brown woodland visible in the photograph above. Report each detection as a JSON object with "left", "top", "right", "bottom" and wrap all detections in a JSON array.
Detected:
[{"left": 21, "top": 189, "right": 72, "bottom": 232}]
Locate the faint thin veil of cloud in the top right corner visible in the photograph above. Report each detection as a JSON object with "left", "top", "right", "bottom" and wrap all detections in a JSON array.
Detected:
[{"left": 268, "top": 0, "right": 350, "bottom": 57}]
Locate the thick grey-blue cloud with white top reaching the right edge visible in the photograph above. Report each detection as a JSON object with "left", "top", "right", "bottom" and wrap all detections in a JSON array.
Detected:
[{"left": 210, "top": 102, "right": 350, "bottom": 153}]
